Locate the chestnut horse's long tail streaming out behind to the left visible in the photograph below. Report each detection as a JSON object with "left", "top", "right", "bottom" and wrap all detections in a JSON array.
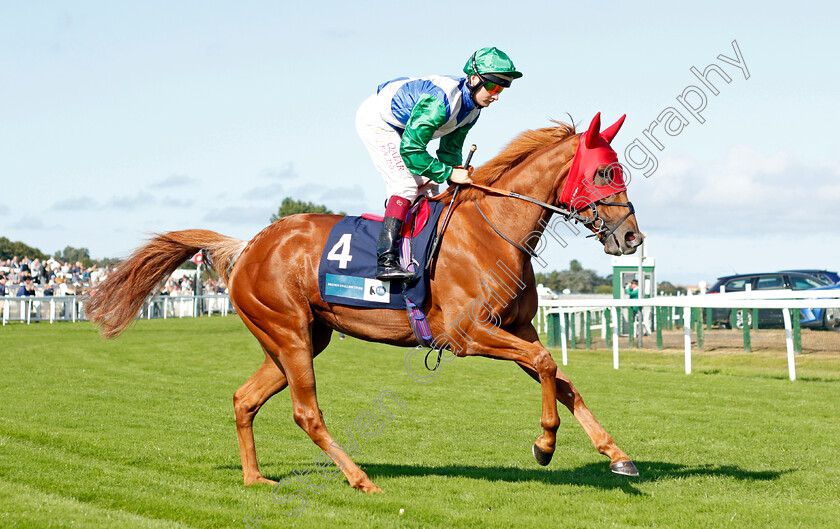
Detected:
[{"left": 85, "top": 230, "right": 248, "bottom": 338}]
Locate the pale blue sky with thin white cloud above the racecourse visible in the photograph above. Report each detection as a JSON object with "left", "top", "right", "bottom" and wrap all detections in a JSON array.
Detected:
[{"left": 0, "top": 0, "right": 840, "bottom": 285}]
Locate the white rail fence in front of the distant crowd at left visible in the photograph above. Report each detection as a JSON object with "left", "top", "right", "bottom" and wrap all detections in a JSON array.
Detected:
[{"left": 0, "top": 294, "right": 233, "bottom": 325}]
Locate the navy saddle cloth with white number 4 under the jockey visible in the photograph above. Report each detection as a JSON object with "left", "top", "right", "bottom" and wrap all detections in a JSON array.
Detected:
[{"left": 318, "top": 197, "right": 443, "bottom": 345}]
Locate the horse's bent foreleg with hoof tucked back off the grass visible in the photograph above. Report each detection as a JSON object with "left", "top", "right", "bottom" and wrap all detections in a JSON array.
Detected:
[{"left": 462, "top": 329, "right": 560, "bottom": 465}]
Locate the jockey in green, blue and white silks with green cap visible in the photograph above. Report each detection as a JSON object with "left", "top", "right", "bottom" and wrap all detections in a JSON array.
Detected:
[{"left": 356, "top": 48, "right": 522, "bottom": 281}]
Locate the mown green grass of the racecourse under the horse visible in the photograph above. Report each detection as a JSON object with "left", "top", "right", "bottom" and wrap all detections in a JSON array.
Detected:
[{"left": 0, "top": 316, "right": 840, "bottom": 529}]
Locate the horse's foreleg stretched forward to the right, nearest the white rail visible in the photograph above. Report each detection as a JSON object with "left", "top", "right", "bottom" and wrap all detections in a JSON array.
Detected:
[{"left": 517, "top": 325, "right": 639, "bottom": 476}]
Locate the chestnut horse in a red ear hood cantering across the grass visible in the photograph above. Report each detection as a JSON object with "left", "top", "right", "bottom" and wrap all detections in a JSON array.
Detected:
[{"left": 86, "top": 116, "right": 642, "bottom": 492}]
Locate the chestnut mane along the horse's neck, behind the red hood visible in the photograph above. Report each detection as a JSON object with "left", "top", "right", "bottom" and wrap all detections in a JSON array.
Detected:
[{"left": 452, "top": 120, "right": 576, "bottom": 202}]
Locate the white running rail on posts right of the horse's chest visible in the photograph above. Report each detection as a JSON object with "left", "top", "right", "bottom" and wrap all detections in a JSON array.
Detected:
[{"left": 538, "top": 290, "right": 840, "bottom": 380}]
